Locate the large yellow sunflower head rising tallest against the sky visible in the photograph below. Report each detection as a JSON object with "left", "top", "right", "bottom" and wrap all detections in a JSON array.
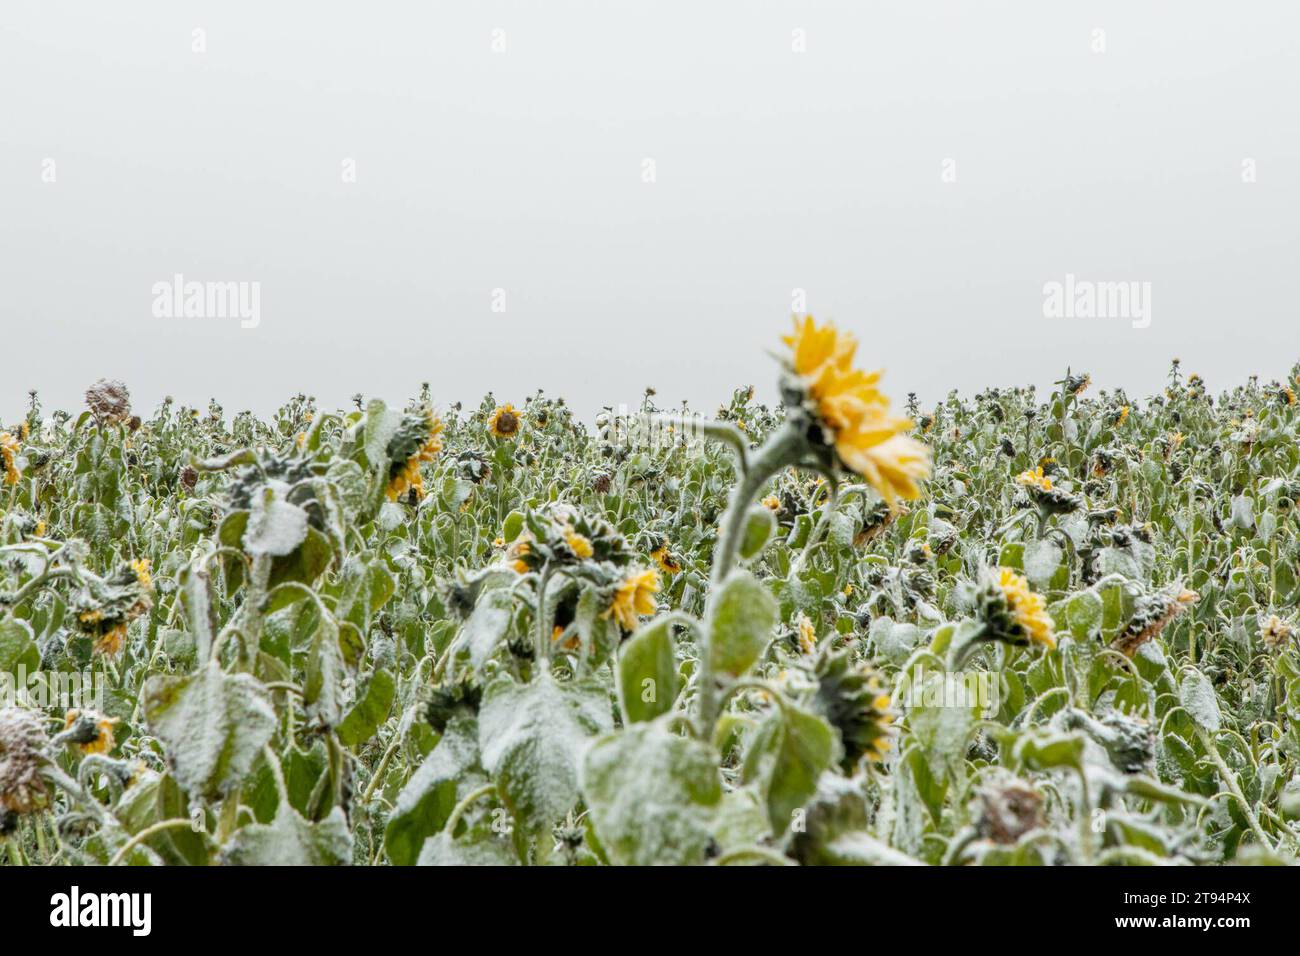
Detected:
[{"left": 783, "top": 316, "right": 930, "bottom": 506}]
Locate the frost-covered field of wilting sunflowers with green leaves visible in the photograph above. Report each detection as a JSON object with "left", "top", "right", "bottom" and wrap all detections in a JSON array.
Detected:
[{"left": 0, "top": 317, "right": 1300, "bottom": 866}]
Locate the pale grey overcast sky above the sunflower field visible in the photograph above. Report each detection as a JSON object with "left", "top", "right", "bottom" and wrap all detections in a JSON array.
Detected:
[{"left": 0, "top": 0, "right": 1300, "bottom": 420}]
